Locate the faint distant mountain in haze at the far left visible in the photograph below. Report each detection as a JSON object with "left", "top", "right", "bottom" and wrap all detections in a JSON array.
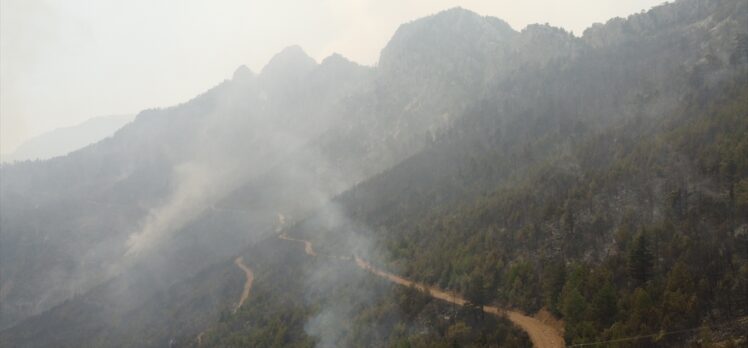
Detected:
[{"left": 3, "top": 115, "right": 133, "bottom": 163}]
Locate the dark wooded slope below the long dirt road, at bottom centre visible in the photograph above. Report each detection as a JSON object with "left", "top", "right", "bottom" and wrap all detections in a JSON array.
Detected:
[{"left": 193, "top": 238, "right": 530, "bottom": 347}]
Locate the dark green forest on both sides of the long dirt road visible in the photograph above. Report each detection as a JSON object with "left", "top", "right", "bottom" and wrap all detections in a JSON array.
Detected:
[{"left": 188, "top": 77, "right": 748, "bottom": 347}]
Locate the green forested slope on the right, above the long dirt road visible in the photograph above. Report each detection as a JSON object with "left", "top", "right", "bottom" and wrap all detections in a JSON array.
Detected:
[{"left": 336, "top": 80, "right": 748, "bottom": 347}]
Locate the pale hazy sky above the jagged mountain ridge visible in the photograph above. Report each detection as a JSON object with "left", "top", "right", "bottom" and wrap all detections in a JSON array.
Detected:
[{"left": 0, "top": 0, "right": 663, "bottom": 153}]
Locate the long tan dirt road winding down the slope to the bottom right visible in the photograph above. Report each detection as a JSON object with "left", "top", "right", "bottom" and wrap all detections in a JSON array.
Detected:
[{"left": 278, "top": 232, "right": 565, "bottom": 348}]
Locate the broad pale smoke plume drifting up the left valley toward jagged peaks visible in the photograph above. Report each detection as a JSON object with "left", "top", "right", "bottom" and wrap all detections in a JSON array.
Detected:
[{"left": 120, "top": 52, "right": 358, "bottom": 259}]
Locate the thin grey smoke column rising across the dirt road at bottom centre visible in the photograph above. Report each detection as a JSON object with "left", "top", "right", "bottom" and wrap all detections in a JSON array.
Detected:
[{"left": 301, "top": 202, "right": 399, "bottom": 347}]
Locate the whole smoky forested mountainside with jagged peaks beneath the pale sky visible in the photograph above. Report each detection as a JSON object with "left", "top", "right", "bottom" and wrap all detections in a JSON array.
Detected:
[{"left": 0, "top": 0, "right": 748, "bottom": 347}]
